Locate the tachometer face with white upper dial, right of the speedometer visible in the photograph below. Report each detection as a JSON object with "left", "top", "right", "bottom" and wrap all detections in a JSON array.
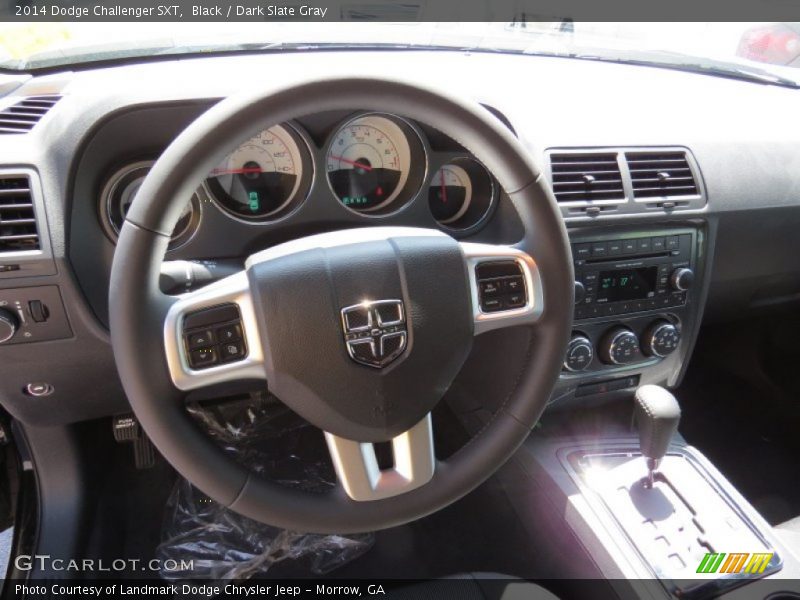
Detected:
[{"left": 326, "top": 115, "right": 411, "bottom": 212}]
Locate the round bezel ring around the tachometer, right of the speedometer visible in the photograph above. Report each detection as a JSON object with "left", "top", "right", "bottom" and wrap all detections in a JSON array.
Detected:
[{"left": 322, "top": 111, "right": 429, "bottom": 218}]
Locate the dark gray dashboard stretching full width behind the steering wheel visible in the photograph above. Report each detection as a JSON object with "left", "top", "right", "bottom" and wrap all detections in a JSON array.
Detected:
[{"left": 0, "top": 51, "right": 800, "bottom": 424}]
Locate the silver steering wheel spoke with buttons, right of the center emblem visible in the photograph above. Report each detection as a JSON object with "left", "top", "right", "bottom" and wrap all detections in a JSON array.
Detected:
[{"left": 461, "top": 242, "right": 544, "bottom": 335}]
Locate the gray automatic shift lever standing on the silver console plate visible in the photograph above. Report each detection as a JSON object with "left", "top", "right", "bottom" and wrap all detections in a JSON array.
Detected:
[{"left": 634, "top": 385, "right": 681, "bottom": 487}]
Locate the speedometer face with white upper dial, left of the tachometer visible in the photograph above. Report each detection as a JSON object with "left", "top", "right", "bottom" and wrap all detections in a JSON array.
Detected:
[{"left": 207, "top": 125, "right": 303, "bottom": 220}]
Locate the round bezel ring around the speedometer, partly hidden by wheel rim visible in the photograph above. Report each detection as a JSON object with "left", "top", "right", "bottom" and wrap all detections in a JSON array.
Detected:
[{"left": 202, "top": 122, "right": 315, "bottom": 225}]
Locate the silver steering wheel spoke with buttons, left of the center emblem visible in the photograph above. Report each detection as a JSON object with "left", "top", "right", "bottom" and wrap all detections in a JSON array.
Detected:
[{"left": 164, "top": 271, "right": 266, "bottom": 391}]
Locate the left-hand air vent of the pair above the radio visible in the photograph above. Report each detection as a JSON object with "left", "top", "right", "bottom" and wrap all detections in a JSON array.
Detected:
[{"left": 550, "top": 152, "right": 626, "bottom": 205}]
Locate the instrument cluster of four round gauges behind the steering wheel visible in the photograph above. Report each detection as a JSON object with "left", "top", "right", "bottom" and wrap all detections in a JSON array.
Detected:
[{"left": 100, "top": 112, "right": 499, "bottom": 250}]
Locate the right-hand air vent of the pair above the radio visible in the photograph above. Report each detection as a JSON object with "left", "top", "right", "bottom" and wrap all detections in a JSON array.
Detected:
[{"left": 625, "top": 151, "right": 699, "bottom": 202}]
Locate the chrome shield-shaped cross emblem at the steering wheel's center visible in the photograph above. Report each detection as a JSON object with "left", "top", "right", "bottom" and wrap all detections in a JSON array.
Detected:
[{"left": 342, "top": 300, "right": 408, "bottom": 369}]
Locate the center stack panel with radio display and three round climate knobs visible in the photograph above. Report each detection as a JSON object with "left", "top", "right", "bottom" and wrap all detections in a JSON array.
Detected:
[{"left": 551, "top": 223, "right": 705, "bottom": 406}]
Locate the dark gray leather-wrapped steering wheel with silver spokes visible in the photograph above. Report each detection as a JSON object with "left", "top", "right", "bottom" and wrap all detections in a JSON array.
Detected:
[{"left": 110, "top": 77, "right": 573, "bottom": 533}]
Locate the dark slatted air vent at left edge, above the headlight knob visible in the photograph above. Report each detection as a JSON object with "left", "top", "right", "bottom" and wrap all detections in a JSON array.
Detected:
[{"left": 0, "top": 176, "right": 40, "bottom": 255}]
